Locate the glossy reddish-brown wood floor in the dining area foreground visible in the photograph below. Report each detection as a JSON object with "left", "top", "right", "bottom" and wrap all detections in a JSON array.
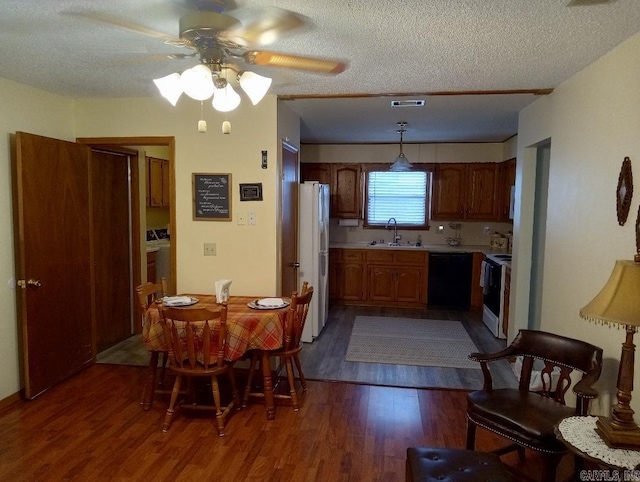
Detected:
[{"left": 0, "top": 364, "right": 572, "bottom": 482}]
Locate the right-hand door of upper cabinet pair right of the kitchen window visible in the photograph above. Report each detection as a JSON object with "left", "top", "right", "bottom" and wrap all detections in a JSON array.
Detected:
[{"left": 467, "top": 162, "right": 498, "bottom": 221}]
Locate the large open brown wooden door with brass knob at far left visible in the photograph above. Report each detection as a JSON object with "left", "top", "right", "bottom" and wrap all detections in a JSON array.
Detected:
[{"left": 13, "top": 132, "right": 95, "bottom": 398}]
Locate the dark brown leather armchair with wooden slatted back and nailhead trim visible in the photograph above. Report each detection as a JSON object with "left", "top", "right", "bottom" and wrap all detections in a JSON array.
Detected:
[{"left": 467, "top": 330, "right": 602, "bottom": 482}]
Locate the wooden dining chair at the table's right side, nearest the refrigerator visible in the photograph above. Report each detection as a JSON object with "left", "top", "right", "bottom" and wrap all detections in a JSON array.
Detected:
[{"left": 242, "top": 281, "right": 313, "bottom": 412}]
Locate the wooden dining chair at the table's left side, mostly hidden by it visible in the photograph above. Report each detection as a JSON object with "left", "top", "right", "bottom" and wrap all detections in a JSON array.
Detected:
[{"left": 136, "top": 277, "right": 170, "bottom": 410}]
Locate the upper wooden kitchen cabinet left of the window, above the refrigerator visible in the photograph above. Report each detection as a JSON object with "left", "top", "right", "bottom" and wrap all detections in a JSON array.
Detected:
[{"left": 300, "top": 163, "right": 362, "bottom": 219}]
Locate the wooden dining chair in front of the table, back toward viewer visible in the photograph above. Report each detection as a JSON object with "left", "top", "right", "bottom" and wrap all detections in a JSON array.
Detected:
[{"left": 160, "top": 304, "right": 240, "bottom": 436}]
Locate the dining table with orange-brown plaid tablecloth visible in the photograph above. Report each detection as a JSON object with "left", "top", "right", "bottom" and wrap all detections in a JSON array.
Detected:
[{"left": 142, "top": 294, "right": 289, "bottom": 420}]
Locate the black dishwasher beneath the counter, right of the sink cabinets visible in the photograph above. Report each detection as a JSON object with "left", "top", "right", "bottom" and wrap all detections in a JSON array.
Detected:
[{"left": 427, "top": 253, "right": 473, "bottom": 310}]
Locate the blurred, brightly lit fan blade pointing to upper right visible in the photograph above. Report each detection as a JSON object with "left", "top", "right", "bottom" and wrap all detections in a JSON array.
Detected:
[{"left": 224, "top": 7, "right": 307, "bottom": 47}]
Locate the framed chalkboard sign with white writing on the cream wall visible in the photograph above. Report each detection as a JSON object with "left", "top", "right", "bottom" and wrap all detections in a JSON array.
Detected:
[{"left": 193, "top": 173, "right": 231, "bottom": 221}]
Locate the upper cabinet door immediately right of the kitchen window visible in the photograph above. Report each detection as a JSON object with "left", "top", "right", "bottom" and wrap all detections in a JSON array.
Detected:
[{"left": 431, "top": 164, "right": 466, "bottom": 221}]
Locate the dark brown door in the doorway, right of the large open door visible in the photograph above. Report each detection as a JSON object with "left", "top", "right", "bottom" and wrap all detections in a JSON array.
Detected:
[{"left": 91, "top": 150, "right": 132, "bottom": 353}]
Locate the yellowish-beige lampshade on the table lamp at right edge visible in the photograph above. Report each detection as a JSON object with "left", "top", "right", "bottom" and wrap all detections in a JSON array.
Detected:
[{"left": 580, "top": 260, "right": 640, "bottom": 326}]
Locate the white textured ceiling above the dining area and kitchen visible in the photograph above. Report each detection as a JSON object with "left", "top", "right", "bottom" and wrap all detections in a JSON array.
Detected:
[{"left": 0, "top": 0, "right": 640, "bottom": 143}]
